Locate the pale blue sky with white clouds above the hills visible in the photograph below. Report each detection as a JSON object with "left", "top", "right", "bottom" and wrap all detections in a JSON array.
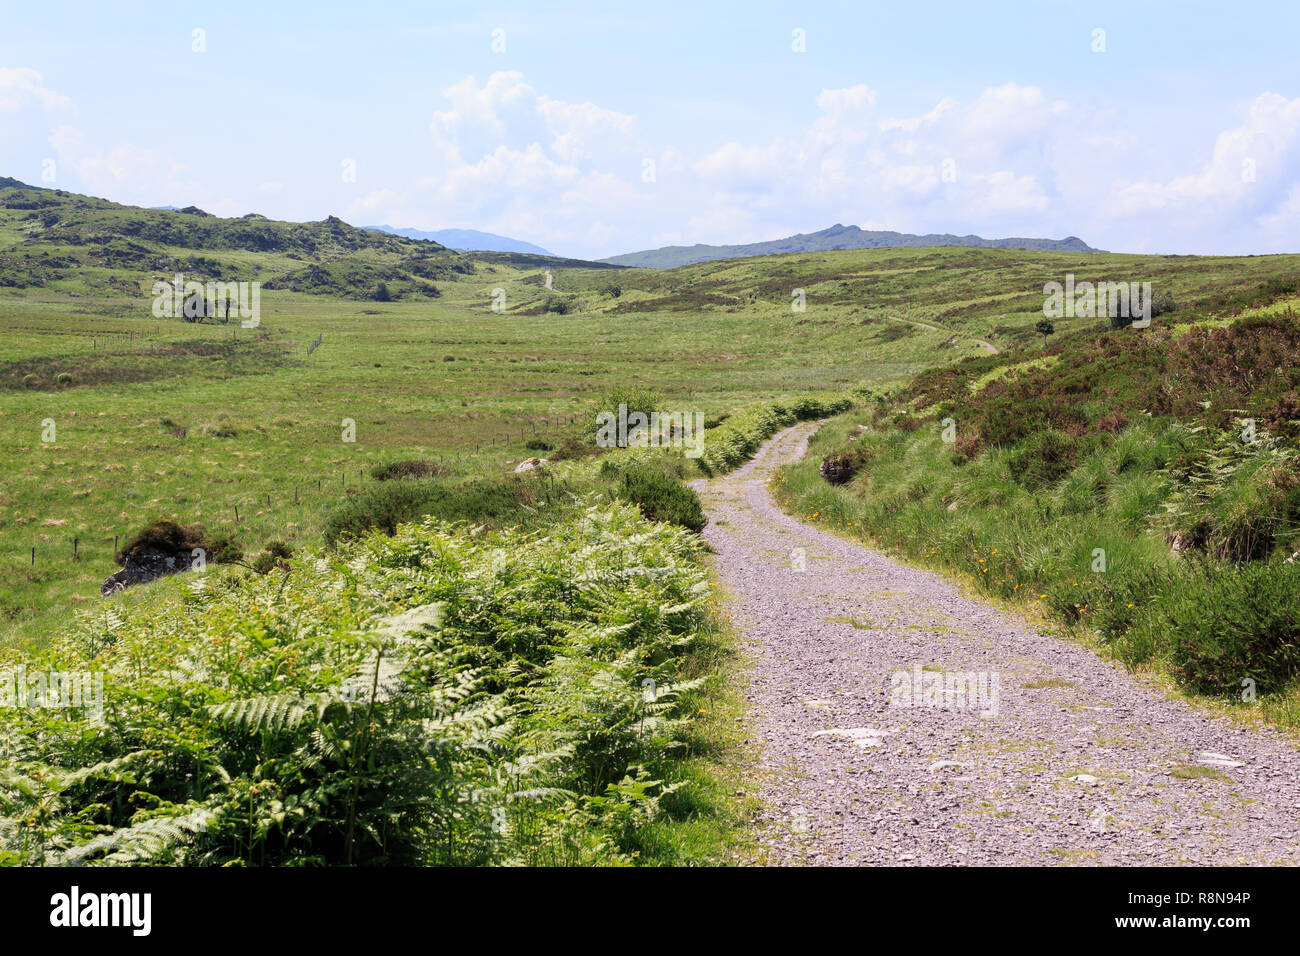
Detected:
[{"left": 0, "top": 1, "right": 1300, "bottom": 258}]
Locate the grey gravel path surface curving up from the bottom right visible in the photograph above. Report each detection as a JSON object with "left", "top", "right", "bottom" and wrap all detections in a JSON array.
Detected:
[{"left": 696, "top": 423, "right": 1300, "bottom": 865}]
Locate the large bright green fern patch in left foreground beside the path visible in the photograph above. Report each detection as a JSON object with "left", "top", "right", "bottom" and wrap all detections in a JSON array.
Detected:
[{"left": 0, "top": 502, "right": 709, "bottom": 865}]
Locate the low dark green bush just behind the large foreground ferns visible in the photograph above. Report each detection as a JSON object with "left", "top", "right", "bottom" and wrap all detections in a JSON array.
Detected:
[{"left": 325, "top": 479, "right": 536, "bottom": 545}]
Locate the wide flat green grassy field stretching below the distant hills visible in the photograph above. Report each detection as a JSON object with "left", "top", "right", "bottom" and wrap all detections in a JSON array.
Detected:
[{"left": 0, "top": 223, "right": 1296, "bottom": 640}]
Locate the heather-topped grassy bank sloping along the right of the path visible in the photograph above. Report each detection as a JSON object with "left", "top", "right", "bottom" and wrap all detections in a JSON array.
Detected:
[{"left": 779, "top": 313, "right": 1300, "bottom": 726}]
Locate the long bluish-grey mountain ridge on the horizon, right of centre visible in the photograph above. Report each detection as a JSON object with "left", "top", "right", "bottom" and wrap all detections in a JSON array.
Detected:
[{"left": 601, "top": 222, "right": 1101, "bottom": 269}]
